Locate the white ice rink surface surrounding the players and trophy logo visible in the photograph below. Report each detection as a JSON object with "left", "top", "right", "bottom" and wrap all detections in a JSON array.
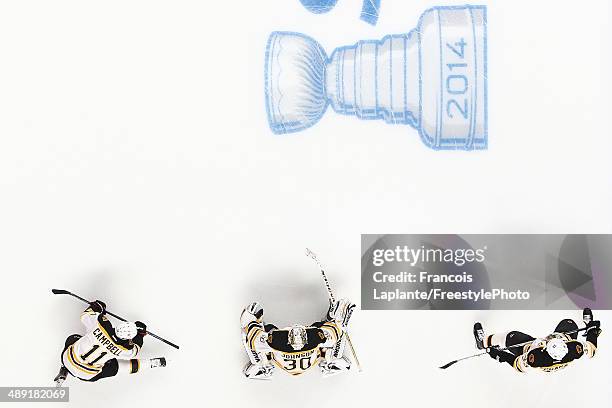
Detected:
[{"left": 0, "top": 0, "right": 612, "bottom": 408}]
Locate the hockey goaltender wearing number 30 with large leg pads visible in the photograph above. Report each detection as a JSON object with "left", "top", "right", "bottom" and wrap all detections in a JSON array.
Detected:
[{"left": 240, "top": 299, "right": 355, "bottom": 380}]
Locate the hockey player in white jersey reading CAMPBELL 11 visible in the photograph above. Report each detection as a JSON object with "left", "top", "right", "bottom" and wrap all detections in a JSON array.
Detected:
[{"left": 54, "top": 300, "right": 166, "bottom": 387}]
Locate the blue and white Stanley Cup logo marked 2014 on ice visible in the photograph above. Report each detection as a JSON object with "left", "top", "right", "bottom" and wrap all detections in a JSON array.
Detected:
[{"left": 265, "top": 6, "right": 487, "bottom": 150}]
